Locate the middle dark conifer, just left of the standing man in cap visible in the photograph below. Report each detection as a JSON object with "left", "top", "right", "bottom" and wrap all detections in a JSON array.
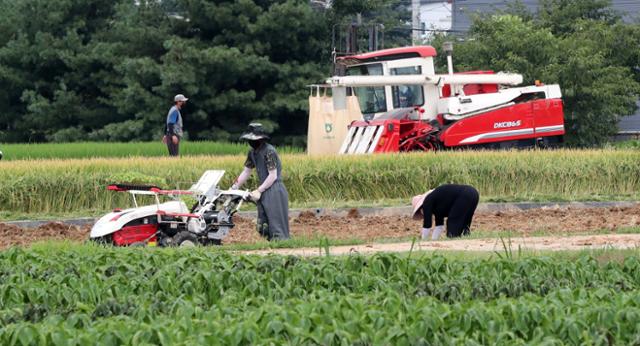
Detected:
[{"left": 89, "top": 1, "right": 175, "bottom": 141}]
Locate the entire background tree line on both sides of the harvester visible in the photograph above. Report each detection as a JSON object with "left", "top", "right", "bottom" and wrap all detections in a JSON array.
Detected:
[{"left": 0, "top": 0, "right": 640, "bottom": 145}]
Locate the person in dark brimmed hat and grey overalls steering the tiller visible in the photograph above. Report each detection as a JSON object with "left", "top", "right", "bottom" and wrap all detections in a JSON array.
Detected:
[{"left": 231, "top": 123, "right": 289, "bottom": 241}]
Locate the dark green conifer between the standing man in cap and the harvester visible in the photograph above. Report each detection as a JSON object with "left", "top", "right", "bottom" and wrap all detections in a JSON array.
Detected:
[{"left": 155, "top": 0, "right": 329, "bottom": 140}]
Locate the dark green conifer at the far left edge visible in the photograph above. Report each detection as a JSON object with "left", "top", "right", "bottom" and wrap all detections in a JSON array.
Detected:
[{"left": 0, "top": 0, "right": 124, "bottom": 141}]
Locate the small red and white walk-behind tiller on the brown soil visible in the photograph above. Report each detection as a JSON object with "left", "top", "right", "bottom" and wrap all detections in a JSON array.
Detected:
[{"left": 90, "top": 170, "right": 250, "bottom": 246}]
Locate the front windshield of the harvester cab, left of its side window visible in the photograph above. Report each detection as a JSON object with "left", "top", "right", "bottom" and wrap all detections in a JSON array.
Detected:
[{"left": 347, "top": 64, "right": 387, "bottom": 114}]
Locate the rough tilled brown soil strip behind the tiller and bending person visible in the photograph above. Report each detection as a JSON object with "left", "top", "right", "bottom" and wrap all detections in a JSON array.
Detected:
[{"left": 0, "top": 205, "right": 640, "bottom": 251}]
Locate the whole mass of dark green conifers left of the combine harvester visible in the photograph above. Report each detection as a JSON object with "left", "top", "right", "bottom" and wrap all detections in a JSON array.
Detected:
[{"left": 0, "top": 0, "right": 410, "bottom": 144}]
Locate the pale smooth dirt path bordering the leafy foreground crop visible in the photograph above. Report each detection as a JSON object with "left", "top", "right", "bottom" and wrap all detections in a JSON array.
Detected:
[{"left": 242, "top": 234, "right": 640, "bottom": 256}]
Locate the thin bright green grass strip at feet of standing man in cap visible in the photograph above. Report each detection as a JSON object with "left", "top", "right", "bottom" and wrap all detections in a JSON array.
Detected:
[{"left": 0, "top": 141, "right": 302, "bottom": 161}]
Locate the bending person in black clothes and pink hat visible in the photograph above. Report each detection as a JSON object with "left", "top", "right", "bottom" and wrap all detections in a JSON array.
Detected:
[{"left": 411, "top": 184, "right": 480, "bottom": 240}]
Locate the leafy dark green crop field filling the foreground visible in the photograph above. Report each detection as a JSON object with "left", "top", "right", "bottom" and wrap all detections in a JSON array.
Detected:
[{"left": 0, "top": 245, "right": 640, "bottom": 345}]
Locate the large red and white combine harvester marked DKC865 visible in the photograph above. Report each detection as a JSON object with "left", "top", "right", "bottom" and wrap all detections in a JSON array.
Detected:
[{"left": 327, "top": 45, "right": 565, "bottom": 154}]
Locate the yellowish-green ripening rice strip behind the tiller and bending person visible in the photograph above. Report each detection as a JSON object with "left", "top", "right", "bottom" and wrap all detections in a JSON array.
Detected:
[{"left": 0, "top": 149, "right": 640, "bottom": 216}]
